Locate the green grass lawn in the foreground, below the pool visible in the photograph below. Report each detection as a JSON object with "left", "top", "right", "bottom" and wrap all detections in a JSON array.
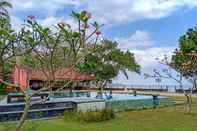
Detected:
[{"left": 0, "top": 96, "right": 197, "bottom": 131}]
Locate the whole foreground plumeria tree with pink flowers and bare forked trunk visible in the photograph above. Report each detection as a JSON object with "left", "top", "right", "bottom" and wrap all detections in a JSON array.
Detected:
[{"left": 0, "top": 11, "right": 104, "bottom": 131}]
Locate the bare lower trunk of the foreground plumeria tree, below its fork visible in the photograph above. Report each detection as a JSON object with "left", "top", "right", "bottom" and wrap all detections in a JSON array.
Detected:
[{"left": 16, "top": 96, "right": 30, "bottom": 131}]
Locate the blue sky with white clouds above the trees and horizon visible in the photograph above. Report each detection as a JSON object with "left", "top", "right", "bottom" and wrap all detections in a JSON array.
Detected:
[{"left": 10, "top": 0, "right": 197, "bottom": 85}]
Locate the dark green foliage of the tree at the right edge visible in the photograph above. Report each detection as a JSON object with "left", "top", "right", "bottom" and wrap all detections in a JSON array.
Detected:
[{"left": 170, "top": 28, "right": 197, "bottom": 88}]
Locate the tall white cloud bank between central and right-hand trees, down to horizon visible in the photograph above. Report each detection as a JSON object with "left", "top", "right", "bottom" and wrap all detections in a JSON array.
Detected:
[{"left": 113, "top": 30, "right": 175, "bottom": 85}]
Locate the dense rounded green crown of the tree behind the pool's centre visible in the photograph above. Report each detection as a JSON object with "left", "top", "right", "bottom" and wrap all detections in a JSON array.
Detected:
[{"left": 77, "top": 40, "right": 140, "bottom": 86}]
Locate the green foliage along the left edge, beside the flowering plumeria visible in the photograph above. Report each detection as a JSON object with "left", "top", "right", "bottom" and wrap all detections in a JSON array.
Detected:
[{"left": 0, "top": 0, "right": 31, "bottom": 80}]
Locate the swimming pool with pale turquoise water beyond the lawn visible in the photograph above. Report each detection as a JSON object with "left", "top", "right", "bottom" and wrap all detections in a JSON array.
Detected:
[{"left": 52, "top": 92, "right": 174, "bottom": 111}]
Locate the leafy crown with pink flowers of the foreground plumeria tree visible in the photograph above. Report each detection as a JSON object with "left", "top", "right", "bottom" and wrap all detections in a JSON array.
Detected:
[{"left": 20, "top": 11, "right": 100, "bottom": 68}]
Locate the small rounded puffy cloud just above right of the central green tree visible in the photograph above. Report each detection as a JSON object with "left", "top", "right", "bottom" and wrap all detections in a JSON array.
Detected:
[{"left": 116, "top": 30, "right": 154, "bottom": 50}]
